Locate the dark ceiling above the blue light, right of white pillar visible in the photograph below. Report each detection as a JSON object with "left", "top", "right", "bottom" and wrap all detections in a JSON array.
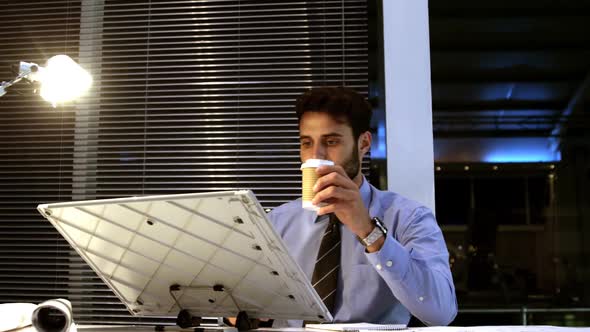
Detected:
[{"left": 429, "top": 0, "right": 590, "bottom": 138}]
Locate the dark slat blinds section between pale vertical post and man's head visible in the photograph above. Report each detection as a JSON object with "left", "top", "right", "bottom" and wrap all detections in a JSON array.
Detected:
[{"left": 88, "top": 1, "right": 367, "bottom": 207}]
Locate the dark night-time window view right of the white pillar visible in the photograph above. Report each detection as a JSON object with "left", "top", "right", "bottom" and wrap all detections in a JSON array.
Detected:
[{"left": 429, "top": 0, "right": 590, "bottom": 326}]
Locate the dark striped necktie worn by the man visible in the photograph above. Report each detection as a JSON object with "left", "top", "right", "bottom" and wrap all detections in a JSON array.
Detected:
[{"left": 311, "top": 214, "right": 341, "bottom": 313}]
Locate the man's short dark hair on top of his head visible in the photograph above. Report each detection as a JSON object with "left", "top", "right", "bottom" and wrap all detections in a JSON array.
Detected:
[{"left": 295, "top": 87, "right": 372, "bottom": 139}]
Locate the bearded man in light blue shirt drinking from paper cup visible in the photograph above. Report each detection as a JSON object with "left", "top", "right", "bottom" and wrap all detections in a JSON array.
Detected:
[{"left": 269, "top": 88, "right": 457, "bottom": 326}]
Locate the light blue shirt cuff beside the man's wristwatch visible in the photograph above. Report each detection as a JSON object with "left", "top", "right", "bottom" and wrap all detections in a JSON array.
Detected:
[{"left": 365, "top": 236, "right": 410, "bottom": 280}]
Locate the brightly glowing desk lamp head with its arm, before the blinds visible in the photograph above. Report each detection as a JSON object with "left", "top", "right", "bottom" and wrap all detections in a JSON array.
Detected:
[{"left": 0, "top": 54, "right": 92, "bottom": 107}]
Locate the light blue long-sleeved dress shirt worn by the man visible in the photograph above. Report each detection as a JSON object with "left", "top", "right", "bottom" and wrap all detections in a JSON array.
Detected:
[{"left": 269, "top": 179, "right": 457, "bottom": 326}]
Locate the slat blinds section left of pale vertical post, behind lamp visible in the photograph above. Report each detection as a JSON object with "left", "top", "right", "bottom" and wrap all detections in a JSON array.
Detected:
[{"left": 0, "top": 1, "right": 86, "bottom": 320}]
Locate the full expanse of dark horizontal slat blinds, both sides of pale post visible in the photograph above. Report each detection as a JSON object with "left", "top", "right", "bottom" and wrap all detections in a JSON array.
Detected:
[{"left": 0, "top": 0, "right": 368, "bottom": 323}]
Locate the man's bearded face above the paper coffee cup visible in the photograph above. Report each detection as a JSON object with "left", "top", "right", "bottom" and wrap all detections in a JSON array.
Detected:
[{"left": 299, "top": 112, "right": 360, "bottom": 180}]
